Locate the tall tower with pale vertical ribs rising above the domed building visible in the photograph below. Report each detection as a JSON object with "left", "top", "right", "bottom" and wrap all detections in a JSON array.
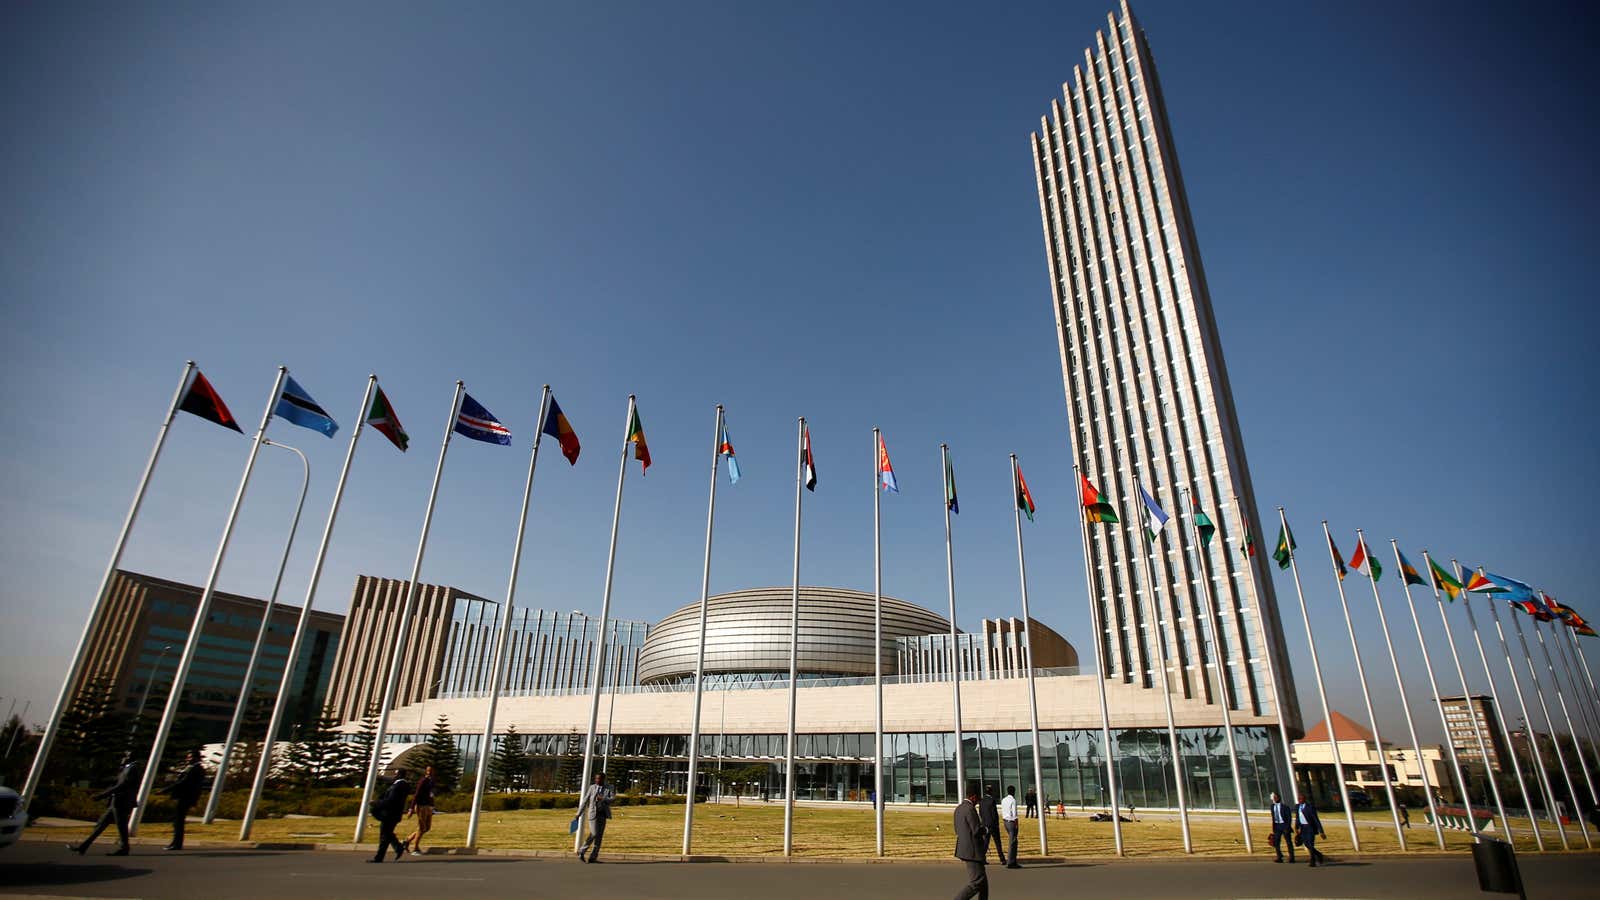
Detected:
[{"left": 1032, "top": 0, "right": 1301, "bottom": 730}]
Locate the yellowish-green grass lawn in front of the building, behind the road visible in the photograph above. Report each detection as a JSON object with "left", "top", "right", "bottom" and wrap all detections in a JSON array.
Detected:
[{"left": 29, "top": 802, "right": 1582, "bottom": 858}]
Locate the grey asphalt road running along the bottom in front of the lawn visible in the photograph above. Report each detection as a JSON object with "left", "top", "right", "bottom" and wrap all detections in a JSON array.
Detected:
[{"left": 0, "top": 841, "right": 1600, "bottom": 900}]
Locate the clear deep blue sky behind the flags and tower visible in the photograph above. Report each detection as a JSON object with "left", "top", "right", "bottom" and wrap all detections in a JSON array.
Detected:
[{"left": 0, "top": 0, "right": 1600, "bottom": 738}]
